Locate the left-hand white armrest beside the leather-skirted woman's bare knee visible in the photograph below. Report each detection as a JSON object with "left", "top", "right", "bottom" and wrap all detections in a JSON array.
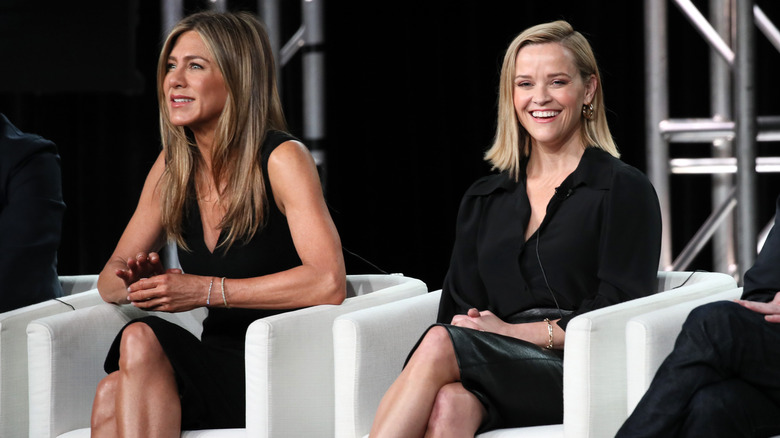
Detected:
[{"left": 333, "top": 291, "right": 441, "bottom": 438}]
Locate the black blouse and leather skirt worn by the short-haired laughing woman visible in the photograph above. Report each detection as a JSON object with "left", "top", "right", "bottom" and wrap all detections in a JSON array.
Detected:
[{"left": 414, "top": 147, "right": 661, "bottom": 431}]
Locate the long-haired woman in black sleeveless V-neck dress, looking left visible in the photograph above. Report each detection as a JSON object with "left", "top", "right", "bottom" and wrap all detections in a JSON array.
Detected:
[{"left": 92, "top": 12, "right": 346, "bottom": 437}]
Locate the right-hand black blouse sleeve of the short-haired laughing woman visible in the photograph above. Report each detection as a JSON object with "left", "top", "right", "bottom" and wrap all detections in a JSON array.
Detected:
[{"left": 558, "top": 167, "right": 661, "bottom": 329}]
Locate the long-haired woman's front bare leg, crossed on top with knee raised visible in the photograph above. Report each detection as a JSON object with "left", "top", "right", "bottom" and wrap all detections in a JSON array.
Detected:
[{"left": 116, "top": 323, "right": 181, "bottom": 438}]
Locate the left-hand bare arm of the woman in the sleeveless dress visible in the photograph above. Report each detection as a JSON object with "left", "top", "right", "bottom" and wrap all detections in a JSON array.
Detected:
[{"left": 98, "top": 153, "right": 165, "bottom": 304}]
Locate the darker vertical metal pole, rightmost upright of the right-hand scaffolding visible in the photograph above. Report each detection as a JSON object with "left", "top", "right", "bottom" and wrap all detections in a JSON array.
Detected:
[{"left": 734, "top": 0, "right": 757, "bottom": 281}]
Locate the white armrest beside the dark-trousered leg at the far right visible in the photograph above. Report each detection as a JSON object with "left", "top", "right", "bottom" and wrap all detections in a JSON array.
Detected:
[{"left": 626, "top": 288, "right": 742, "bottom": 414}]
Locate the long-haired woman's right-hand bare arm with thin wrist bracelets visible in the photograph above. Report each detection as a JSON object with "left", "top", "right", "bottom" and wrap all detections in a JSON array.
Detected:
[{"left": 96, "top": 141, "right": 346, "bottom": 312}]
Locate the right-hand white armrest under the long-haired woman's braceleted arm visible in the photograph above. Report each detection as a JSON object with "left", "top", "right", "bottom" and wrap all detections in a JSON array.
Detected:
[{"left": 246, "top": 275, "right": 428, "bottom": 437}]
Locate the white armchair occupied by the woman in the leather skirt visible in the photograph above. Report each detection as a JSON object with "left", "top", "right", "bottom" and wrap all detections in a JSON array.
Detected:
[{"left": 333, "top": 272, "right": 736, "bottom": 438}]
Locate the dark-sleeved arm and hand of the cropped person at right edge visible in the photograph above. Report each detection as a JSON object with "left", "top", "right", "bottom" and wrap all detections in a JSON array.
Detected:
[{"left": 735, "top": 197, "right": 780, "bottom": 322}]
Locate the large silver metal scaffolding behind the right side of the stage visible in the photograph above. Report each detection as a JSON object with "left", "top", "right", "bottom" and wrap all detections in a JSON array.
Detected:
[{"left": 645, "top": 0, "right": 780, "bottom": 278}]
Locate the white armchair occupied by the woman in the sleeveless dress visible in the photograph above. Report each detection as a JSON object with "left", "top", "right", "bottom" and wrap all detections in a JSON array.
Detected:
[{"left": 27, "top": 275, "right": 428, "bottom": 438}]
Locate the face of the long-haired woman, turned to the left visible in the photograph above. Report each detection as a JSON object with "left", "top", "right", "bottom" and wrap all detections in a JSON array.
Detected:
[{"left": 165, "top": 31, "right": 228, "bottom": 138}]
